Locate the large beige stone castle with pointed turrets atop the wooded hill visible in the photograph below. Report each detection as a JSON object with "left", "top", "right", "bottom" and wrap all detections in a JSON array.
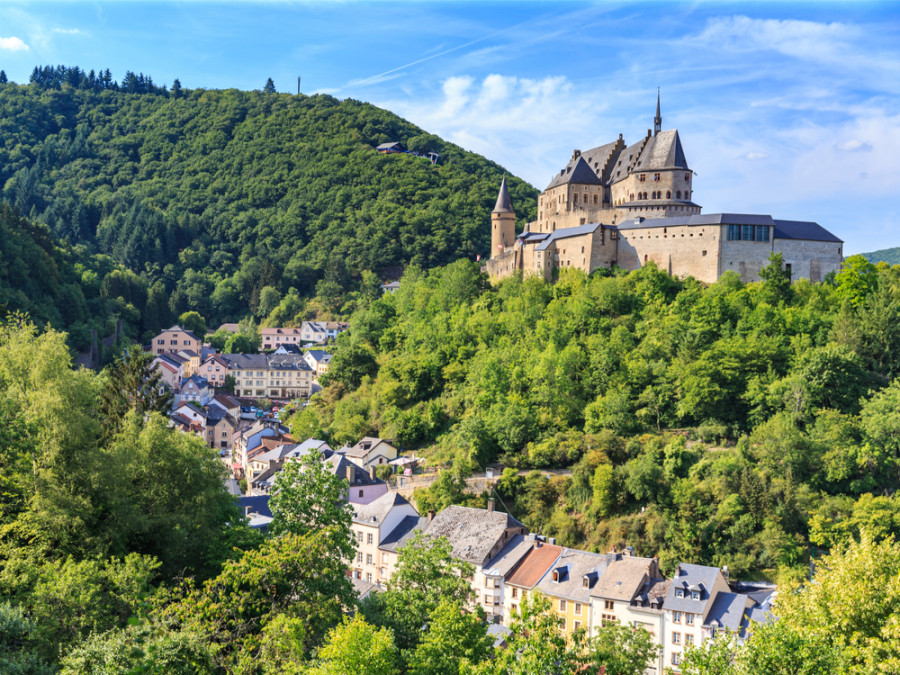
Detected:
[{"left": 485, "top": 96, "right": 843, "bottom": 283}]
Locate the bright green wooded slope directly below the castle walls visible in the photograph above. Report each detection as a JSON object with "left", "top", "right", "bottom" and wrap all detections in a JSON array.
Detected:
[{"left": 294, "top": 257, "right": 900, "bottom": 575}]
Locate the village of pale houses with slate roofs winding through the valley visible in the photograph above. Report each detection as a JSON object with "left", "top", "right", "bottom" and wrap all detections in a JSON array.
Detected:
[{"left": 144, "top": 321, "right": 777, "bottom": 673}]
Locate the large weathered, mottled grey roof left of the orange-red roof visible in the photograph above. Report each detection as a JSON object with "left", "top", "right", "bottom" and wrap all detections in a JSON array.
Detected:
[{"left": 425, "top": 506, "right": 525, "bottom": 565}]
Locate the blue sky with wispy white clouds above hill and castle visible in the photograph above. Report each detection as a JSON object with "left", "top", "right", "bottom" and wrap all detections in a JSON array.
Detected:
[{"left": 0, "top": 0, "right": 900, "bottom": 253}]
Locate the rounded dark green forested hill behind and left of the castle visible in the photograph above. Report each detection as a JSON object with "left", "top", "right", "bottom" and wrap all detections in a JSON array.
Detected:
[{"left": 0, "top": 67, "right": 537, "bottom": 337}]
